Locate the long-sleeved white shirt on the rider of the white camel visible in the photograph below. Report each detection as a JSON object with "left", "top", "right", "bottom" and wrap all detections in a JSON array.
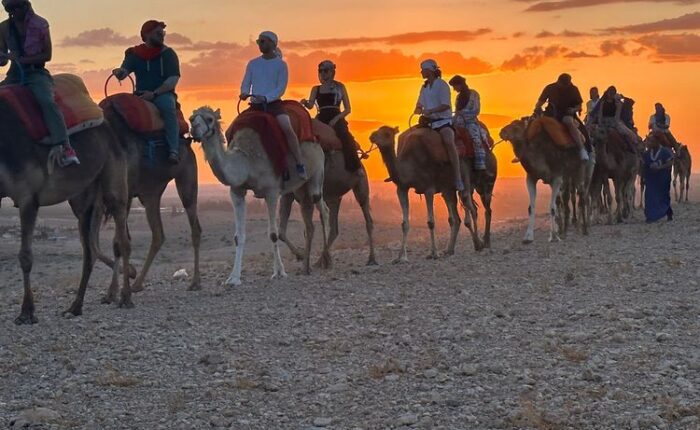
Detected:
[{"left": 241, "top": 56, "right": 289, "bottom": 103}]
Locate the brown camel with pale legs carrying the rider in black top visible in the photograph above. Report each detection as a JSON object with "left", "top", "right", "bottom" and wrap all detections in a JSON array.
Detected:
[{"left": 500, "top": 118, "right": 592, "bottom": 244}]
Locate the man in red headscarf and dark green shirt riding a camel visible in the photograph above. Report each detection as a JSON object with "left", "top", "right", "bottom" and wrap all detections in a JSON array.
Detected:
[{"left": 112, "top": 20, "right": 180, "bottom": 164}]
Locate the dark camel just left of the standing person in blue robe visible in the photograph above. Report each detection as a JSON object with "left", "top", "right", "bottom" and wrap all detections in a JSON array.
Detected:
[{"left": 590, "top": 127, "right": 639, "bottom": 224}]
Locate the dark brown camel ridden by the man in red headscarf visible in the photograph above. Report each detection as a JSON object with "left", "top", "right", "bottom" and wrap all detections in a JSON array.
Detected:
[{"left": 95, "top": 105, "right": 202, "bottom": 292}]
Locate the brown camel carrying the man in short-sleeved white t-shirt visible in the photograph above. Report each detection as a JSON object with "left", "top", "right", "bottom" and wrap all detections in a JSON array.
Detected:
[{"left": 370, "top": 122, "right": 483, "bottom": 263}]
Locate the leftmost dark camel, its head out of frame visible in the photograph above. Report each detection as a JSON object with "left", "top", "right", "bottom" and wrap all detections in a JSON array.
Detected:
[{"left": 0, "top": 98, "right": 133, "bottom": 324}]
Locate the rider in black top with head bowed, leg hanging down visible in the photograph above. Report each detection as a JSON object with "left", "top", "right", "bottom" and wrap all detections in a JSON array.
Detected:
[{"left": 534, "top": 73, "right": 589, "bottom": 161}]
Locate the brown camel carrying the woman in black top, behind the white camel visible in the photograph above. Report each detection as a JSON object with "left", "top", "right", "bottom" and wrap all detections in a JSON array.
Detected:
[{"left": 279, "top": 119, "right": 377, "bottom": 266}]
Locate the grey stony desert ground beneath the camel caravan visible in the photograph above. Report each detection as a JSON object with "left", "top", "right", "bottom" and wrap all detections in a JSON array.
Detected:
[{"left": 0, "top": 179, "right": 700, "bottom": 430}]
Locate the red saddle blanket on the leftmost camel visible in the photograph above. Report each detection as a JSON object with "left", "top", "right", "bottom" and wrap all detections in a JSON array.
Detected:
[{"left": 0, "top": 73, "right": 104, "bottom": 142}]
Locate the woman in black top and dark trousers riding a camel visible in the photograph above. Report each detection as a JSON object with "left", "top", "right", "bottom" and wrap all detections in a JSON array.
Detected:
[{"left": 301, "top": 60, "right": 362, "bottom": 172}]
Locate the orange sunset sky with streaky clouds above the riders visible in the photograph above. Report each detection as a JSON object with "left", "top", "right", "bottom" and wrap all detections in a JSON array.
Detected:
[{"left": 23, "top": 0, "right": 700, "bottom": 182}]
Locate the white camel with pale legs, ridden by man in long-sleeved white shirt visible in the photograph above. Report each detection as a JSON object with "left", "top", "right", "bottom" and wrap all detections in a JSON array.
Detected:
[{"left": 190, "top": 106, "right": 330, "bottom": 286}]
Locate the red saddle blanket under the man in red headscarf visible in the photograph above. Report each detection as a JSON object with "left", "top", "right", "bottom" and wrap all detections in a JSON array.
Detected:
[{"left": 100, "top": 93, "right": 190, "bottom": 136}]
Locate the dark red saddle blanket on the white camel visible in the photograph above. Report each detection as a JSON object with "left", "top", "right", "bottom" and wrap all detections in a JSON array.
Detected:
[{"left": 226, "top": 100, "right": 316, "bottom": 176}]
